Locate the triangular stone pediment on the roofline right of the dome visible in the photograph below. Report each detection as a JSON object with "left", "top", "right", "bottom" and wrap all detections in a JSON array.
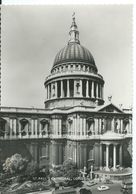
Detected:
[{"left": 98, "top": 103, "right": 123, "bottom": 113}]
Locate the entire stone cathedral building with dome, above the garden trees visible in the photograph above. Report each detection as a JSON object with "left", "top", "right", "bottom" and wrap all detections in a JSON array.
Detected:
[{"left": 0, "top": 17, "right": 132, "bottom": 170}]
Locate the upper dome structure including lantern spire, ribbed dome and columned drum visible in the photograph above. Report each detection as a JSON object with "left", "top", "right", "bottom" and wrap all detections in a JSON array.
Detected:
[{"left": 44, "top": 13, "right": 104, "bottom": 108}]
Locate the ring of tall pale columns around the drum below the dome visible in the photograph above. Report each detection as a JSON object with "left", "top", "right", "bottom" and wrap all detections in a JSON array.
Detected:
[{"left": 46, "top": 78, "right": 103, "bottom": 100}]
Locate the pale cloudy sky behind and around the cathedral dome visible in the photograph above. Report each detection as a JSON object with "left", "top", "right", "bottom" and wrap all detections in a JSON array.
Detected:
[{"left": 1, "top": 5, "right": 132, "bottom": 108}]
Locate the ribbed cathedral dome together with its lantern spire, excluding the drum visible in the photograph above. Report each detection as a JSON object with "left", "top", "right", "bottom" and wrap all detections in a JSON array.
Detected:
[{"left": 53, "top": 12, "right": 96, "bottom": 68}]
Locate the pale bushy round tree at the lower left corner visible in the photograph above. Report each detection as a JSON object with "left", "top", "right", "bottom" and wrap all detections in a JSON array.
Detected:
[{"left": 3, "top": 154, "right": 28, "bottom": 174}]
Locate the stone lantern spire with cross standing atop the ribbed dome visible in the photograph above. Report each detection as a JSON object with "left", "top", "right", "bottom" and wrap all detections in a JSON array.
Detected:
[{"left": 68, "top": 12, "right": 80, "bottom": 44}]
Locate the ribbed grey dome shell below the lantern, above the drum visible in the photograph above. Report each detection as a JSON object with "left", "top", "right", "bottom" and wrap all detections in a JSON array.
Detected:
[{"left": 53, "top": 42, "right": 95, "bottom": 67}]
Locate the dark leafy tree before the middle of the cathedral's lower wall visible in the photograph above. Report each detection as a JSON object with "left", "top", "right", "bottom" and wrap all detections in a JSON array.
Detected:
[{"left": 62, "top": 159, "right": 79, "bottom": 180}]
